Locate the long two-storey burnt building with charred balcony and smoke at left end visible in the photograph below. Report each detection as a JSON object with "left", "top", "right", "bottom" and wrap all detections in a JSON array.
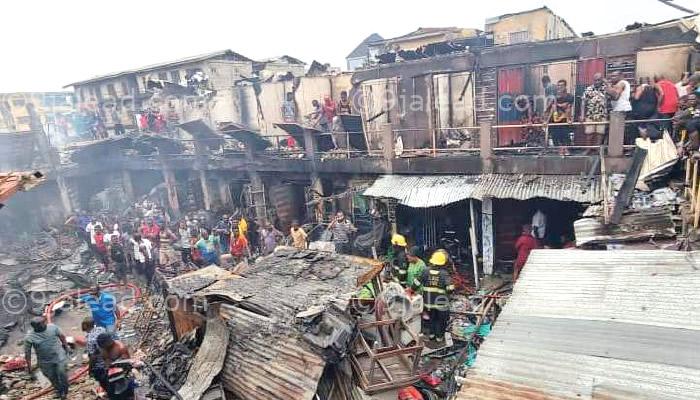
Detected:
[{"left": 2, "top": 14, "right": 698, "bottom": 274}]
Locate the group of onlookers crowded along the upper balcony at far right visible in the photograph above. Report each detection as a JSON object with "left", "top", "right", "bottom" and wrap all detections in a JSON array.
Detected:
[{"left": 516, "top": 71, "right": 700, "bottom": 155}]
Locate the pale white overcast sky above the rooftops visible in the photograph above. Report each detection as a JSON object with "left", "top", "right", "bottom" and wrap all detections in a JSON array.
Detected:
[{"left": 0, "top": 0, "right": 700, "bottom": 92}]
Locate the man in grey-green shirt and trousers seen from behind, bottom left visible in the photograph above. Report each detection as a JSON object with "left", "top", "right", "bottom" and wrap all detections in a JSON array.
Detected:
[{"left": 24, "top": 317, "right": 68, "bottom": 400}]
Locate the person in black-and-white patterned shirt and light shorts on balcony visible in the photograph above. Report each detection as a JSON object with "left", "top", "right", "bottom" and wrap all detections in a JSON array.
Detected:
[{"left": 579, "top": 72, "right": 608, "bottom": 146}]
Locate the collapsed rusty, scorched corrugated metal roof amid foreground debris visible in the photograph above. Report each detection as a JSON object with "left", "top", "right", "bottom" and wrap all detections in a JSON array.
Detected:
[{"left": 189, "top": 248, "right": 382, "bottom": 400}]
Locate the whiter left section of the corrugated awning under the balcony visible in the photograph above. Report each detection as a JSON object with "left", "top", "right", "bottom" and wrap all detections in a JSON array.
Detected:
[{"left": 364, "top": 175, "right": 480, "bottom": 208}]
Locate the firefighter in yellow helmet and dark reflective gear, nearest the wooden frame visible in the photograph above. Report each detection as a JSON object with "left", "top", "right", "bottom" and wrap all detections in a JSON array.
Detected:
[{"left": 420, "top": 249, "right": 454, "bottom": 341}]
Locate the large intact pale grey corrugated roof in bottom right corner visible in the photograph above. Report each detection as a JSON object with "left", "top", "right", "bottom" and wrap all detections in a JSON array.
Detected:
[{"left": 458, "top": 250, "right": 700, "bottom": 400}]
